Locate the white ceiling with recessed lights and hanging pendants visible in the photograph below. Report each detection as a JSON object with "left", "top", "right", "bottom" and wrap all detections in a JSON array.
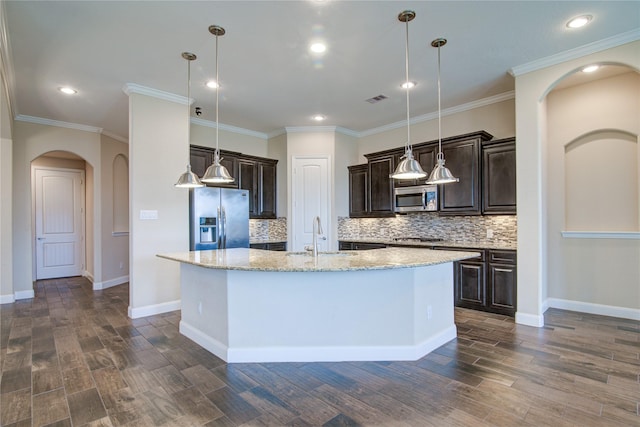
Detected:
[{"left": 3, "top": 0, "right": 640, "bottom": 139}]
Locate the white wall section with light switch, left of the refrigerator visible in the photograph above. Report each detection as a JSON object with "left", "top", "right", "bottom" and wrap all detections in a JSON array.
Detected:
[{"left": 129, "top": 92, "right": 189, "bottom": 318}]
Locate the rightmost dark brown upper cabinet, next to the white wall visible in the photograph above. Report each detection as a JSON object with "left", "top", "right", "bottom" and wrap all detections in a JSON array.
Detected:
[{"left": 482, "top": 138, "right": 516, "bottom": 215}]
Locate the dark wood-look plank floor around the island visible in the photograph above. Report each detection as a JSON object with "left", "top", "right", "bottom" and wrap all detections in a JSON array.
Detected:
[{"left": 0, "top": 278, "right": 640, "bottom": 427}]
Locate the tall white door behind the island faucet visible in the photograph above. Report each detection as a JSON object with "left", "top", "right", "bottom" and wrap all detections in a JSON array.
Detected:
[{"left": 292, "top": 157, "right": 332, "bottom": 251}]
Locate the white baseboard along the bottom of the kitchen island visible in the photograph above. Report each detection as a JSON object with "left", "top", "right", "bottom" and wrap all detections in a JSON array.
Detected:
[{"left": 180, "top": 321, "right": 457, "bottom": 363}]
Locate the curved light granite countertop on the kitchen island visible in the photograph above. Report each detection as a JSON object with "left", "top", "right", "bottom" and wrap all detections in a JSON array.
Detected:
[{"left": 157, "top": 248, "right": 478, "bottom": 272}]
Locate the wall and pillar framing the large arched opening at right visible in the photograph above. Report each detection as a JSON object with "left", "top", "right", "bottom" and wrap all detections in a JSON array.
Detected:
[{"left": 516, "top": 42, "right": 640, "bottom": 326}]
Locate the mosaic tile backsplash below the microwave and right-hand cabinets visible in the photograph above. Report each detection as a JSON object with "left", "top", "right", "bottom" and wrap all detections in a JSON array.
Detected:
[{"left": 338, "top": 216, "right": 518, "bottom": 244}]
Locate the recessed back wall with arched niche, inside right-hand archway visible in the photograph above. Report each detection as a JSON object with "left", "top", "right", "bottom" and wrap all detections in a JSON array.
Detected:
[{"left": 544, "top": 72, "right": 640, "bottom": 317}]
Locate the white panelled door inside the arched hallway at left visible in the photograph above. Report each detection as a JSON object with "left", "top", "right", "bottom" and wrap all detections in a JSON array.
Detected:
[{"left": 35, "top": 169, "right": 84, "bottom": 279}]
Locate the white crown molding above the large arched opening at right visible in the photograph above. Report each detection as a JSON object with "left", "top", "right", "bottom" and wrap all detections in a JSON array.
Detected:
[{"left": 509, "top": 29, "right": 640, "bottom": 77}]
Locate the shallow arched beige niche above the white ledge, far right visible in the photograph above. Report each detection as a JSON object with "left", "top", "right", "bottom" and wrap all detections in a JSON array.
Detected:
[{"left": 564, "top": 129, "right": 640, "bottom": 231}]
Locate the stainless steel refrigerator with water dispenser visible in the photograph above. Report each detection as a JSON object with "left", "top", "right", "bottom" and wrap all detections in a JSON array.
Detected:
[{"left": 189, "top": 187, "right": 249, "bottom": 251}]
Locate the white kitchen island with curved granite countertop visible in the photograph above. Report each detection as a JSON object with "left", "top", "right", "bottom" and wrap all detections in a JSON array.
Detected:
[{"left": 158, "top": 248, "right": 477, "bottom": 363}]
